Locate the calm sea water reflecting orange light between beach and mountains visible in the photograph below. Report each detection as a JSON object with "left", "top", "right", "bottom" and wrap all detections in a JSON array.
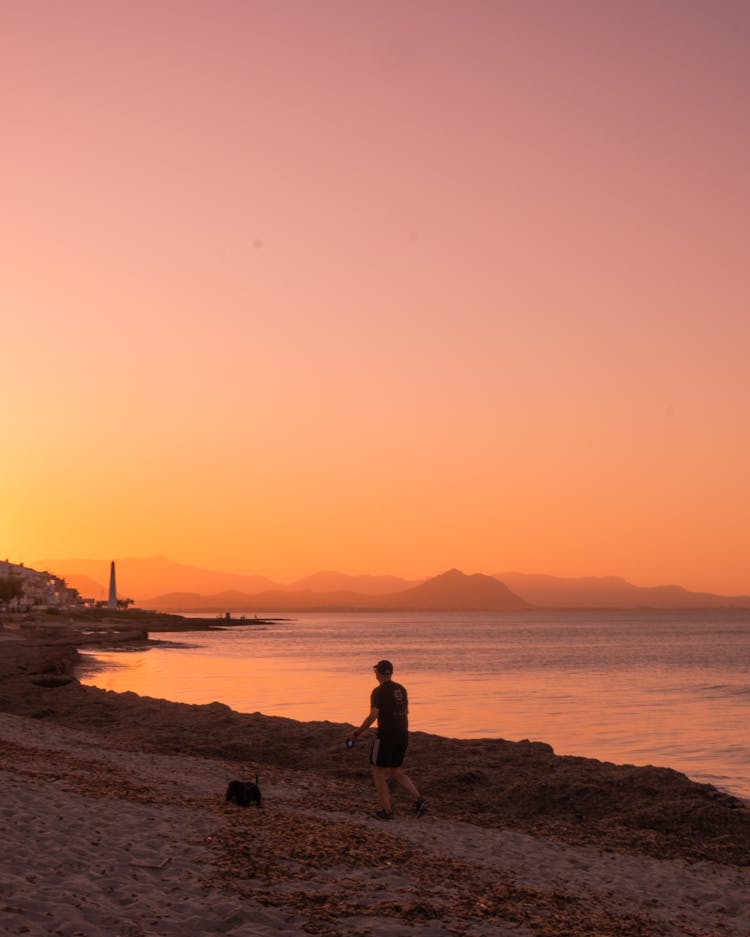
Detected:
[{"left": 81, "top": 611, "right": 750, "bottom": 798}]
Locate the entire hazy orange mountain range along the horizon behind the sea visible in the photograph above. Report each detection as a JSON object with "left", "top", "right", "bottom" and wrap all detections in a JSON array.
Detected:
[{"left": 35, "top": 557, "right": 750, "bottom": 612}]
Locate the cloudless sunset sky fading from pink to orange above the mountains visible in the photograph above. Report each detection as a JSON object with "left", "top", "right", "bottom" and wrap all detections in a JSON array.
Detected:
[{"left": 0, "top": 0, "right": 750, "bottom": 594}]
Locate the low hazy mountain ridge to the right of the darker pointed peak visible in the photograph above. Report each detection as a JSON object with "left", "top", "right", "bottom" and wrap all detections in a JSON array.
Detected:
[{"left": 496, "top": 573, "right": 750, "bottom": 609}]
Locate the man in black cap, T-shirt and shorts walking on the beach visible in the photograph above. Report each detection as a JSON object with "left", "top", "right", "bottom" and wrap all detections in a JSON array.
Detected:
[{"left": 352, "top": 660, "right": 426, "bottom": 820}]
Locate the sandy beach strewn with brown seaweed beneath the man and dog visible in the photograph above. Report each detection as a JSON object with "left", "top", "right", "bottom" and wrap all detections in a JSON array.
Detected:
[{"left": 0, "top": 625, "right": 750, "bottom": 937}]
